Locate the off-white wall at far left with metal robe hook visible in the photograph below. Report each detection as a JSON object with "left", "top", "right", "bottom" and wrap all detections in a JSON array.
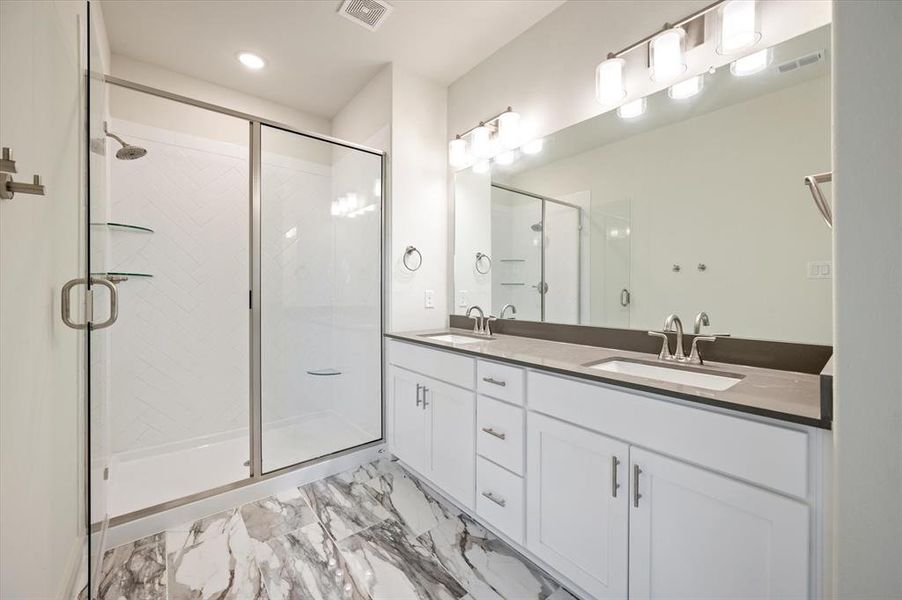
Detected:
[{"left": 0, "top": 2, "right": 93, "bottom": 600}]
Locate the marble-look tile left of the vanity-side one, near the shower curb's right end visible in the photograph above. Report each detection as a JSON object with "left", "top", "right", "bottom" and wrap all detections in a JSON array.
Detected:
[{"left": 301, "top": 475, "right": 389, "bottom": 541}]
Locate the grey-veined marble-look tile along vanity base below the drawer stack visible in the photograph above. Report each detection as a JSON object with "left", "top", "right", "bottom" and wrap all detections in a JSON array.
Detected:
[{"left": 419, "top": 515, "right": 559, "bottom": 600}]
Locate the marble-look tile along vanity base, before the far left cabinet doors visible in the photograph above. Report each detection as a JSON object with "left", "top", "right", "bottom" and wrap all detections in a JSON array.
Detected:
[{"left": 365, "top": 461, "right": 460, "bottom": 536}]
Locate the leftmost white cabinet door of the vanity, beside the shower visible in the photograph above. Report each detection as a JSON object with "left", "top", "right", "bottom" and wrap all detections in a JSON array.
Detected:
[{"left": 390, "top": 367, "right": 429, "bottom": 475}]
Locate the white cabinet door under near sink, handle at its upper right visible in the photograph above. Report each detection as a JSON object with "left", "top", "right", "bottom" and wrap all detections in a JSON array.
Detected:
[{"left": 526, "top": 413, "right": 629, "bottom": 598}]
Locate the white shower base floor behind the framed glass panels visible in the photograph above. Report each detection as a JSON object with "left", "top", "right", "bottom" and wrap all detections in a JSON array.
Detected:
[{"left": 107, "top": 411, "right": 376, "bottom": 517}]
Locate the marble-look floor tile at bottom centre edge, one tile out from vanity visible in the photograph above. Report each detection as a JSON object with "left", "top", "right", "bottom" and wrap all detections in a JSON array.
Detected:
[{"left": 338, "top": 519, "right": 467, "bottom": 600}]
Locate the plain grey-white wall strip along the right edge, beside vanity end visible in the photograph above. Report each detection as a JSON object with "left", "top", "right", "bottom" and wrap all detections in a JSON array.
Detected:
[{"left": 833, "top": 2, "right": 902, "bottom": 598}]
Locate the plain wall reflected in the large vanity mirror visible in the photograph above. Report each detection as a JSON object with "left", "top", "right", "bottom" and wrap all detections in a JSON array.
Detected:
[{"left": 512, "top": 77, "right": 833, "bottom": 345}]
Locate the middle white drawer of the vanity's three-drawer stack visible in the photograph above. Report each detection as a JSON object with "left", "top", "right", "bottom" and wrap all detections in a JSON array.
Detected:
[{"left": 476, "top": 395, "right": 526, "bottom": 475}]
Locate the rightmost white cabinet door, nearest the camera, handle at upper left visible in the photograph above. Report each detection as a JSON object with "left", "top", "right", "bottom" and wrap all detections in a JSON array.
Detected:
[{"left": 629, "top": 448, "right": 808, "bottom": 599}]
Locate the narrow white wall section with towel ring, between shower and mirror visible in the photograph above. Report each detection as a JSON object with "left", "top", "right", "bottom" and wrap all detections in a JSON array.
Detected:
[{"left": 387, "top": 66, "right": 448, "bottom": 331}]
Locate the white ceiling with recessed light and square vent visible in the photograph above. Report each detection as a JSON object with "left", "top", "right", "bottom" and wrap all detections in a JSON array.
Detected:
[{"left": 102, "top": 0, "right": 564, "bottom": 118}]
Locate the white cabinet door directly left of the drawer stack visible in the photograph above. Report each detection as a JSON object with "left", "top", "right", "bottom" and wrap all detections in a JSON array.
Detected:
[{"left": 424, "top": 379, "right": 476, "bottom": 508}]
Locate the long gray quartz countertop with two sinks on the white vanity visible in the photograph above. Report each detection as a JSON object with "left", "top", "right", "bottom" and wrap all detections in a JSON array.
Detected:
[{"left": 385, "top": 329, "right": 831, "bottom": 429}]
